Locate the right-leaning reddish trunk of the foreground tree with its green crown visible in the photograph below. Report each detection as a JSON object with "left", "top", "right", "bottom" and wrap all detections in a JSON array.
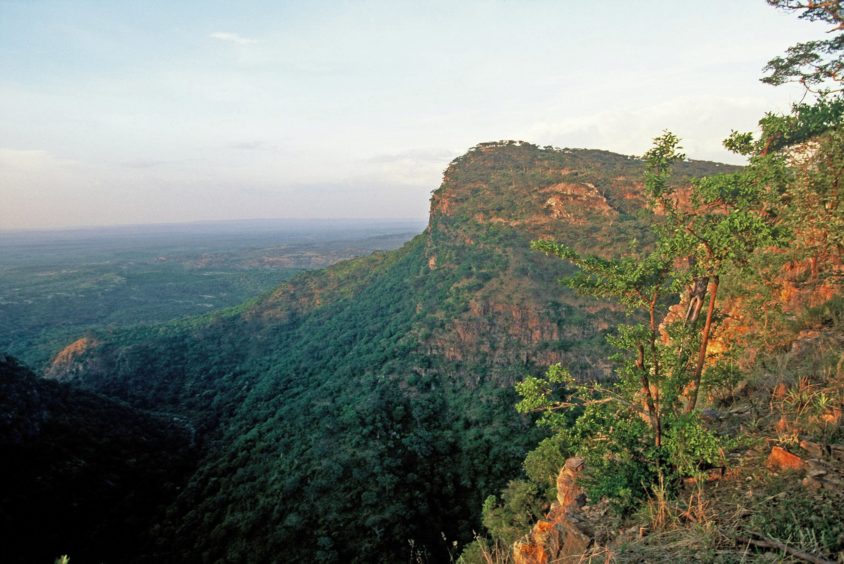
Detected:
[{"left": 645, "top": 134, "right": 789, "bottom": 413}]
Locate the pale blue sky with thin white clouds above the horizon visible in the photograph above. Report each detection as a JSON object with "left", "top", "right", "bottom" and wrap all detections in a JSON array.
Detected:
[{"left": 0, "top": 0, "right": 825, "bottom": 231}]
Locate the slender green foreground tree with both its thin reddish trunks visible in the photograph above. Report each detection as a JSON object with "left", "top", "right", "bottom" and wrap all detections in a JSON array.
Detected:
[{"left": 518, "top": 123, "right": 783, "bottom": 458}]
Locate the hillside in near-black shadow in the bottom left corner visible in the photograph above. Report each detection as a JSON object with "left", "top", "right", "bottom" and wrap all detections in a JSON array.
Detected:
[{"left": 0, "top": 354, "right": 196, "bottom": 562}]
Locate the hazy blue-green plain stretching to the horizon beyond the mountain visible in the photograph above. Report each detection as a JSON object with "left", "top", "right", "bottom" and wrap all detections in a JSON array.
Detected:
[{"left": 0, "top": 219, "right": 425, "bottom": 370}]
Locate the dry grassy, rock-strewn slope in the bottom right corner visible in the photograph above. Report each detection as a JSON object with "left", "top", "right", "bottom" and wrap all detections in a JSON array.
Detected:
[{"left": 611, "top": 331, "right": 844, "bottom": 563}]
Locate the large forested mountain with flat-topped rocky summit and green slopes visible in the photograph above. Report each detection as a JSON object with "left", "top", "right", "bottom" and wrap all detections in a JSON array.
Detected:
[{"left": 36, "top": 142, "right": 727, "bottom": 562}]
